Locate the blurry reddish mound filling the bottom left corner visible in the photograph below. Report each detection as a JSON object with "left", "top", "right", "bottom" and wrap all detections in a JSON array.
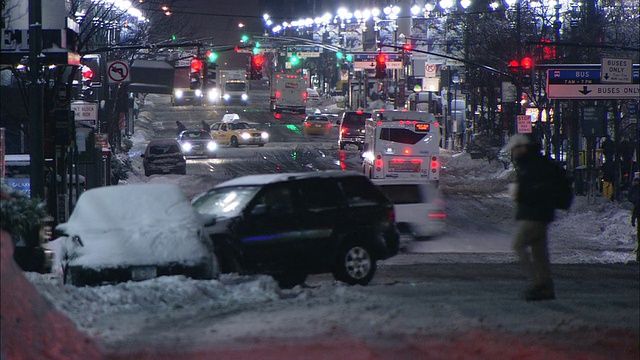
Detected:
[{"left": 0, "top": 231, "right": 101, "bottom": 360}]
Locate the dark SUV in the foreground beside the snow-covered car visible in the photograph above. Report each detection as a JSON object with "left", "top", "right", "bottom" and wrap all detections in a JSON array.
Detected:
[{"left": 193, "top": 171, "right": 398, "bottom": 287}]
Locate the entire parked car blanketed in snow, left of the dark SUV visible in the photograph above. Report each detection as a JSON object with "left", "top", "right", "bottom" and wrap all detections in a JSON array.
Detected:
[{"left": 56, "top": 184, "right": 218, "bottom": 286}]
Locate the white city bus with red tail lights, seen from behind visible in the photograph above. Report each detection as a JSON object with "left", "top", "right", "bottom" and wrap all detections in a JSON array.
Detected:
[{"left": 362, "top": 110, "right": 441, "bottom": 182}]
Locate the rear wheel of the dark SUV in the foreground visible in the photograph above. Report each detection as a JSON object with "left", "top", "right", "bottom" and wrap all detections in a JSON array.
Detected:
[{"left": 333, "top": 243, "right": 376, "bottom": 285}]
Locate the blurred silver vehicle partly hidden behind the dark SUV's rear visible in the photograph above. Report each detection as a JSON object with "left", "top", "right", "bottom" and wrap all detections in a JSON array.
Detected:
[{"left": 373, "top": 179, "right": 447, "bottom": 239}]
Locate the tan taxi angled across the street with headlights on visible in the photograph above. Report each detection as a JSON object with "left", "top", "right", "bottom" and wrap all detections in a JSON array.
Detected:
[{"left": 211, "top": 120, "right": 269, "bottom": 147}]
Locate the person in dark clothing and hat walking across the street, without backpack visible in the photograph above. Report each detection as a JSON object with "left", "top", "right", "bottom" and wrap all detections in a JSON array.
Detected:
[{"left": 507, "top": 134, "right": 556, "bottom": 301}]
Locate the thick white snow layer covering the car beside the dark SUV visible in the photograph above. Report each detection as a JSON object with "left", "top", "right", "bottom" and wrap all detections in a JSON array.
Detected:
[{"left": 58, "top": 184, "right": 208, "bottom": 268}]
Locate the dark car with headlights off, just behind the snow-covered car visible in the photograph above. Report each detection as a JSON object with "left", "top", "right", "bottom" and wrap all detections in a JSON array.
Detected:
[{"left": 140, "top": 139, "right": 187, "bottom": 176}]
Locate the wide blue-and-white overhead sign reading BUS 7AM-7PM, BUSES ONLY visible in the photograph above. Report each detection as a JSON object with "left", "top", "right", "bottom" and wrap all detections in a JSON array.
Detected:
[{"left": 547, "top": 68, "right": 640, "bottom": 100}]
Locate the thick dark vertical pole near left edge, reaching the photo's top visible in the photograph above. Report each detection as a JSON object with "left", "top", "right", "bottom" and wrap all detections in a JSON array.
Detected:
[{"left": 29, "top": 0, "right": 44, "bottom": 199}]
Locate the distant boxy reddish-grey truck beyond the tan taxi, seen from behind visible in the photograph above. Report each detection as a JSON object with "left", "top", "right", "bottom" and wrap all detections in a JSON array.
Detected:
[{"left": 270, "top": 72, "right": 308, "bottom": 114}]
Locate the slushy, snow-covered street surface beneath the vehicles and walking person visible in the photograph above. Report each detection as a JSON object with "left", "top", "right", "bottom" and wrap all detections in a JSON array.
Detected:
[{"left": 2, "top": 96, "right": 640, "bottom": 360}]
